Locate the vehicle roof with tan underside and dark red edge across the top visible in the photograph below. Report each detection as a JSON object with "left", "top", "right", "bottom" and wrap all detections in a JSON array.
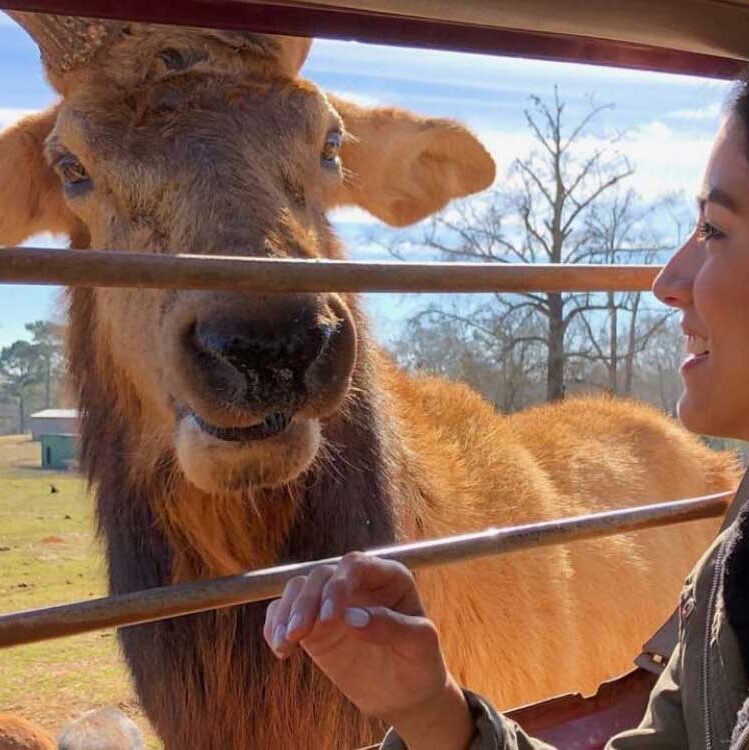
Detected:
[{"left": 0, "top": 0, "right": 749, "bottom": 77}]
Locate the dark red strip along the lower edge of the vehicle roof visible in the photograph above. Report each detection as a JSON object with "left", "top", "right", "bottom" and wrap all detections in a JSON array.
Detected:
[{"left": 0, "top": 0, "right": 744, "bottom": 78}]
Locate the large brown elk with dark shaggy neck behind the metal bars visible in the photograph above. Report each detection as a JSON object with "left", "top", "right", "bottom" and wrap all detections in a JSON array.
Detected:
[{"left": 0, "top": 12, "right": 736, "bottom": 750}]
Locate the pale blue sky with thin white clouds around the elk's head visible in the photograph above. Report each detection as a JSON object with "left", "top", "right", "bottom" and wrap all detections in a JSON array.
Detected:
[{"left": 0, "top": 12, "right": 728, "bottom": 347}]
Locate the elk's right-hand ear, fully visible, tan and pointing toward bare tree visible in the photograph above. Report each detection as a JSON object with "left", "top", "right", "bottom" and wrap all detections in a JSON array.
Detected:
[{"left": 328, "top": 95, "right": 496, "bottom": 227}]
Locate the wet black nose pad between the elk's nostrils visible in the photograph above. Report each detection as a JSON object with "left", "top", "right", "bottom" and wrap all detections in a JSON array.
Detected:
[{"left": 195, "top": 318, "right": 333, "bottom": 382}]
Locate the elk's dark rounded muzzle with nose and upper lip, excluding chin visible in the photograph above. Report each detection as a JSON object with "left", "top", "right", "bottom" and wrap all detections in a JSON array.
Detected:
[{"left": 173, "top": 295, "right": 356, "bottom": 442}]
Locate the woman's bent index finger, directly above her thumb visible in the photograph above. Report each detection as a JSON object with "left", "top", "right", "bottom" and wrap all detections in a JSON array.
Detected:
[{"left": 321, "top": 552, "right": 424, "bottom": 622}]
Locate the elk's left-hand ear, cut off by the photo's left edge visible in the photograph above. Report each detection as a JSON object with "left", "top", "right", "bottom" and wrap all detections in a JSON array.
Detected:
[{"left": 0, "top": 106, "right": 78, "bottom": 245}]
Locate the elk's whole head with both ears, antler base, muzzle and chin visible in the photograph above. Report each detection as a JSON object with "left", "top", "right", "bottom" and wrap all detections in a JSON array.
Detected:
[{"left": 0, "top": 13, "right": 494, "bottom": 493}]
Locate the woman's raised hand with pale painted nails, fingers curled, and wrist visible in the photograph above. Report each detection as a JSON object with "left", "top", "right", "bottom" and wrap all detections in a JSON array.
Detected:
[{"left": 264, "top": 553, "right": 473, "bottom": 750}]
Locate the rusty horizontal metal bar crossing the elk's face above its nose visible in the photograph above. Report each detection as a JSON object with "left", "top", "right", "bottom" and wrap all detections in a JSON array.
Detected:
[{"left": 0, "top": 247, "right": 660, "bottom": 293}]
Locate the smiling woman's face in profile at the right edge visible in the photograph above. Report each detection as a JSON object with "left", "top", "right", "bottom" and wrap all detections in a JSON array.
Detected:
[{"left": 653, "top": 115, "right": 749, "bottom": 440}]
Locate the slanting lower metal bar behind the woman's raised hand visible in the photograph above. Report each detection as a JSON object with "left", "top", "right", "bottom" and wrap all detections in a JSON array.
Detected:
[{"left": 0, "top": 492, "right": 734, "bottom": 648}]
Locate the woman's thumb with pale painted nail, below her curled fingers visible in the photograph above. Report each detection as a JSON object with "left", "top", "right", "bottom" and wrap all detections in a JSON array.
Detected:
[{"left": 343, "top": 607, "right": 440, "bottom": 660}]
